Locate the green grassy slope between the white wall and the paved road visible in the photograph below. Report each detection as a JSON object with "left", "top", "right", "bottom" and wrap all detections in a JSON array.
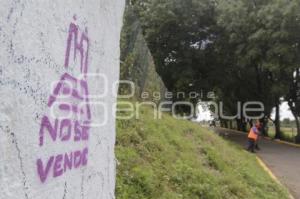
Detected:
[{"left": 116, "top": 105, "right": 288, "bottom": 199}]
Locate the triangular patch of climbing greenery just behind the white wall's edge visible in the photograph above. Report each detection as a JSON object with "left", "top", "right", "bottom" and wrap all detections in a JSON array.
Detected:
[{"left": 119, "top": 4, "right": 165, "bottom": 101}]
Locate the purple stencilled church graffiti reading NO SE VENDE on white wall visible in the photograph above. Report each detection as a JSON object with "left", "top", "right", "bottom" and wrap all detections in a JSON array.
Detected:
[{"left": 36, "top": 17, "right": 91, "bottom": 183}]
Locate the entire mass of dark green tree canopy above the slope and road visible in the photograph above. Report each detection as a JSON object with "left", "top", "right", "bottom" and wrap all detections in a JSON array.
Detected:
[{"left": 130, "top": 0, "right": 300, "bottom": 137}]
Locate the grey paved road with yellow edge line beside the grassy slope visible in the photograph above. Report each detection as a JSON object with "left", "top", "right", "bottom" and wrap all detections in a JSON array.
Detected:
[{"left": 215, "top": 128, "right": 300, "bottom": 199}]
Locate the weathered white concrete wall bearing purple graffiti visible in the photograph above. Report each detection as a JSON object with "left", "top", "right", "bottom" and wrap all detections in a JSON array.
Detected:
[{"left": 0, "top": 0, "right": 124, "bottom": 199}]
